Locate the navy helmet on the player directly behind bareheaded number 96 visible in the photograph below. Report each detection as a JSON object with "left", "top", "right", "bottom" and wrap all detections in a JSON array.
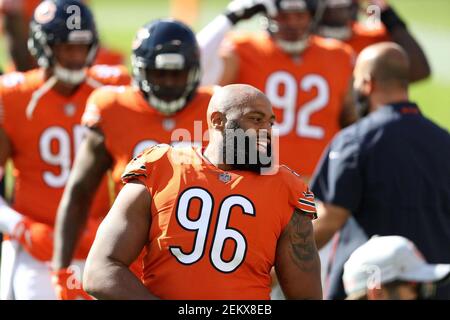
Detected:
[{"left": 131, "top": 19, "right": 200, "bottom": 114}]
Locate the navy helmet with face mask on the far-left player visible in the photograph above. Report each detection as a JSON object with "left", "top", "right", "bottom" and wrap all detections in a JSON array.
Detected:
[{"left": 28, "top": 0, "right": 98, "bottom": 84}]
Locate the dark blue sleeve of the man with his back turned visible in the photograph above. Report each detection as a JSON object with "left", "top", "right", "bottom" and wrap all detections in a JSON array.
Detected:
[{"left": 310, "top": 128, "right": 363, "bottom": 212}]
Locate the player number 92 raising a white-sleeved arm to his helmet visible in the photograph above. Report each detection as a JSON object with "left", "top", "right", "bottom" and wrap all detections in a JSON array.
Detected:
[{"left": 198, "top": 0, "right": 356, "bottom": 178}]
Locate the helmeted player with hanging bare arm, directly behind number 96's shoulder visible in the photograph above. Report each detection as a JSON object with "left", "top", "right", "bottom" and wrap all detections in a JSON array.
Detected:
[{"left": 53, "top": 19, "right": 213, "bottom": 296}]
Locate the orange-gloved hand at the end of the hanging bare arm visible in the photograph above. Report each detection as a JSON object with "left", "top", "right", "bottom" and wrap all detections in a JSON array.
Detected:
[{"left": 52, "top": 268, "right": 93, "bottom": 300}]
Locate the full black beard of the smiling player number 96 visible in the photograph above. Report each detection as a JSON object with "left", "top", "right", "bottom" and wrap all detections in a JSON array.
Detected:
[{"left": 222, "top": 120, "right": 273, "bottom": 174}]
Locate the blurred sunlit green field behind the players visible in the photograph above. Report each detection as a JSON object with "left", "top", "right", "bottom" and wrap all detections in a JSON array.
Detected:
[{"left": 0, "top": 0, "right": 450, "bottom": 130}]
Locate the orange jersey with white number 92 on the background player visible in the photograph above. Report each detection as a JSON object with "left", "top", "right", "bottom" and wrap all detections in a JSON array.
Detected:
[{"left": 223, "top": 32, "right": 354, "bottom": 176}]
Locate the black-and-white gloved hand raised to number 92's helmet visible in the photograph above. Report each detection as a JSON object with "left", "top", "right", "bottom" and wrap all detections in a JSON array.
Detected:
[{"left": 225, "top": 0, "right": 278, "bottom": 24}]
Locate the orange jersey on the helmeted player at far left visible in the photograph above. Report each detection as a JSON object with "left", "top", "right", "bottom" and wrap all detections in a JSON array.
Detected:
[{"left": 0, "top": 65, "right": 130, "bottom": 230}]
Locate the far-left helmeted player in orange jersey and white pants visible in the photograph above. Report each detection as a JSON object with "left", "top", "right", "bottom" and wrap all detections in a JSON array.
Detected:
[{"left": 0, "top": 0, "right": 130, "bottom": 300}]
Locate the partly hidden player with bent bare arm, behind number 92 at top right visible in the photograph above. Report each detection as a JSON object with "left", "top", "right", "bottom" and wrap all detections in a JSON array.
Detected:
[{"left": 316, "top": 0, "right": 431, "bottom": 82}]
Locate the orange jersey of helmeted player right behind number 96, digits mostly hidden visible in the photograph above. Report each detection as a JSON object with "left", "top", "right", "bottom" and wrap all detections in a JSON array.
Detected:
[{"left": 82, "top": 86, "right": 213, "bottom": 195}]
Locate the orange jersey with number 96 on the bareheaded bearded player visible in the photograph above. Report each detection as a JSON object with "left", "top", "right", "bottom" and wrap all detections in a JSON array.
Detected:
[{"left": 123, "top": 145, "right": 316, "bottom": 299}]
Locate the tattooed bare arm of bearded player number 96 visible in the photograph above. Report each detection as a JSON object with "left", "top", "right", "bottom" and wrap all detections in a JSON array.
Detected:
[{"left": 275, "top": 209, "right": 322, "bottom": 300}]
